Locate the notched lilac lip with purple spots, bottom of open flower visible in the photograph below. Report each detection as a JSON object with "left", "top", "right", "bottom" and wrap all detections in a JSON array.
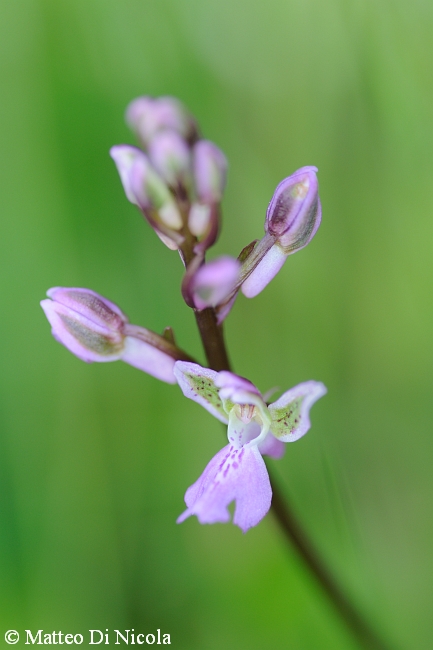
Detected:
[{"left": 177, "top": 446, "right": 272, "bottom": 533}]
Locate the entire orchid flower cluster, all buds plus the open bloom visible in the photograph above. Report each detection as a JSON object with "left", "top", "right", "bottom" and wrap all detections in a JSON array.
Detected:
[{"left": 41, "top": 97, "right": 326, "bottom": 531}]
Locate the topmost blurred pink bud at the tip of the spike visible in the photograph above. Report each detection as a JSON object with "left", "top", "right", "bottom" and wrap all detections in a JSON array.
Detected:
[{"left": 126, "top": 97, "right": 197, "bottom": 147}]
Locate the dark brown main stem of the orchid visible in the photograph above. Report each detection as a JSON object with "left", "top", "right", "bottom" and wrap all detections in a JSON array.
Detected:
[{"left": 194, "top": 308, "right": 388, "bottom": 650}]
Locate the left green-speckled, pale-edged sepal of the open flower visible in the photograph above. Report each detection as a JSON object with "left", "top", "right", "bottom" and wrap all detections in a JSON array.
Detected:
[{"left": 174, "top": 361, "right": 228, "bottom": 424}]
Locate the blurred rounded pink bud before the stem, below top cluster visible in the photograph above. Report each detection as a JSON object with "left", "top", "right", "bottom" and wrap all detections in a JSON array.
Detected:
[{"left": 189, "top": 256, "right": 240, "bottom": 309}]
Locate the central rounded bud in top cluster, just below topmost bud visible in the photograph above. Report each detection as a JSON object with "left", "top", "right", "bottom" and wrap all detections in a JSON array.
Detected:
[{"left": 149, "top": 131, "right": 191, "bottom": 188}]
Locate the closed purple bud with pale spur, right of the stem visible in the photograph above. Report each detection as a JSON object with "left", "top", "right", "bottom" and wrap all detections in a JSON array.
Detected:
[{"left": 242, "top": 167, "right": 322, "bottom": 298}]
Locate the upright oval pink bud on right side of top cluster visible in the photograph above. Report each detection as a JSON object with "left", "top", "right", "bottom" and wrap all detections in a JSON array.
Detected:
[{"left": 193, "top": 140, "right": 227, "bottom": 204}]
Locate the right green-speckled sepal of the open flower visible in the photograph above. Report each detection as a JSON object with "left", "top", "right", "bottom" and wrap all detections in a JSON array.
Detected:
[{"left": 268, "top": 381, "right": 326, "bottom": 442}]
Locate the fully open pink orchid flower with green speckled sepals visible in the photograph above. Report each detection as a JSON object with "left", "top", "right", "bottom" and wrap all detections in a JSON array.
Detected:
[{"left": 174, "top": 361, "right": 326, "bottom": 532}]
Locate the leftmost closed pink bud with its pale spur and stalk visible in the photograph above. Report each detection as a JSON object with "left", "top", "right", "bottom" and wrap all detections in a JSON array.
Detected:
[{"left": 41, "top": 287, "right": 189, "bottom": 384}]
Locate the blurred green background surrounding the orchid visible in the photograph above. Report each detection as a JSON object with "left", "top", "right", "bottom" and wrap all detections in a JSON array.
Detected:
[{"left": 0, "top": 0, "right": 433, "bottom": 650}]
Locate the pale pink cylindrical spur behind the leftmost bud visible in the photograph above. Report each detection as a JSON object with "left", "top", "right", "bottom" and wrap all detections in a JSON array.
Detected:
[{"left": 121, "top": 336, "right": 176, "bottom": 384}]
